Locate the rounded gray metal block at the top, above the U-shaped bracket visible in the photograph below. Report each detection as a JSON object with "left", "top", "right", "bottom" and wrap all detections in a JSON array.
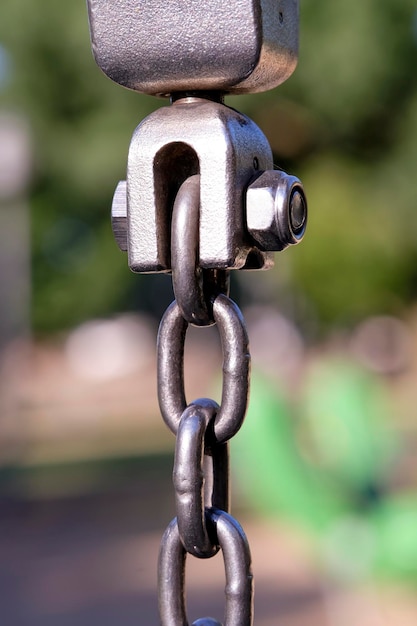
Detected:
[{"left": 87, "top": 0, "right": 298, "bottom": 95}]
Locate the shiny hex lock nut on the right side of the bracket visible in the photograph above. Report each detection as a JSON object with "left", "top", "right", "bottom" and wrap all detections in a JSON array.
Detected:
[{"left": 246, "top": 170, "right": 307, "bottom": 252}]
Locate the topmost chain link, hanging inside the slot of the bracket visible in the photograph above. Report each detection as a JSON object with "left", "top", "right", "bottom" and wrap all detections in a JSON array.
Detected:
[{"left": 171, "top": 174, "right": 229, "bottom": 326}]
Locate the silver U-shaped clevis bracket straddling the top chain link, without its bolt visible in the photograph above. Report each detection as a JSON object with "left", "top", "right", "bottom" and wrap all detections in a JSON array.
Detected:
[{"left": 127, "top": 98, "right": 273, "bottom": 272}]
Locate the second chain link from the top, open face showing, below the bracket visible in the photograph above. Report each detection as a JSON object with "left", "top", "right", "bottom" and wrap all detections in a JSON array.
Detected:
[{"left": 158, "top": 294, "right": 250, "bottom": 443}]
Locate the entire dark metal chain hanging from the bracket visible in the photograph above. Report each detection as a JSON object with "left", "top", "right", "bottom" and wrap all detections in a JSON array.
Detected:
[{"left": 158, "top": 176, "right": 253, "bottom": 626}]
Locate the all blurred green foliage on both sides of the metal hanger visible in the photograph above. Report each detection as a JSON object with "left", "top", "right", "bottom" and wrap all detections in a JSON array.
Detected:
[{"left": 0, "top": 0, "right": 417, "bottom": 332}]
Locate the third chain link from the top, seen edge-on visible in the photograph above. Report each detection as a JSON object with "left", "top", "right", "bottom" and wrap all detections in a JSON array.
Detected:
[{"left": 173, "top": 399, "right": 229, "bottom": 558}]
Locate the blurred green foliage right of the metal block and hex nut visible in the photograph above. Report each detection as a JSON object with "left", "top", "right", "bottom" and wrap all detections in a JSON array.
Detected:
[{"left": 235, "top": 0, "right": 417, "bottom": 328}]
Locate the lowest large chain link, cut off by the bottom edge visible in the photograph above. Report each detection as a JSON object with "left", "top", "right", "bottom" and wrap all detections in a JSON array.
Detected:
[{"left": 158, "top": 509, "right": 253, "bottom": 626}]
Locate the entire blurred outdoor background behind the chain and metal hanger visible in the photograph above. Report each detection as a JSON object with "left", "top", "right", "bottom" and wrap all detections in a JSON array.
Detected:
[{"left": 0, "top": 0, "right": 417, "bottom": 626}]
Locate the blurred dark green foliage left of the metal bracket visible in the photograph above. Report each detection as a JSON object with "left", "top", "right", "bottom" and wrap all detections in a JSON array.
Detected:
[{"left": 0, "top": 0, "right": 160, "bottom": 332}]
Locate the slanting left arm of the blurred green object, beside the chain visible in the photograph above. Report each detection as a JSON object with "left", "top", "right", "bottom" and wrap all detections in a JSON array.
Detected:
[{"left": 232, "top": 371, "right": 348, "bottom": 532}]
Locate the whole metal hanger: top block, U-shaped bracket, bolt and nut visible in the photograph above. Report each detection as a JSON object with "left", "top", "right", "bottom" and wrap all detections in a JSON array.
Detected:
[{"left": 87, "top": 0, "right": 307, "bottom": 272}]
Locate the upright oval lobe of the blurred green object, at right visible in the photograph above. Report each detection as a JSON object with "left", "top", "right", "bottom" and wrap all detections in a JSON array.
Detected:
[{"left": 299, "top": 358, "right": 396, "bottom": 492}]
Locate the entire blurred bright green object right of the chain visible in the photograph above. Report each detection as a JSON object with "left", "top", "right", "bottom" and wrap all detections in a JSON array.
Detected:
[{"left": 233, "top": 358, "right": 417, "bottom": 581}]
